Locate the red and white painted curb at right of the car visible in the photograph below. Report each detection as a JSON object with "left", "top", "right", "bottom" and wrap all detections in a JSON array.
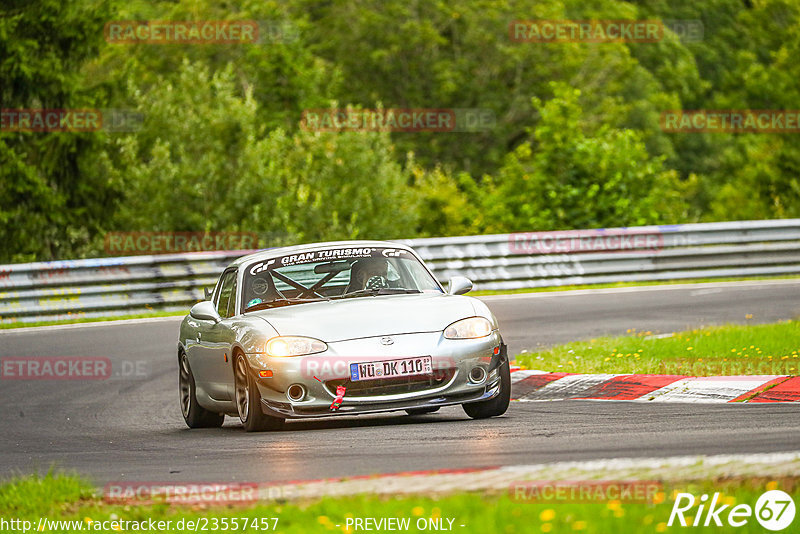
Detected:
[{"left": 511, "top": 369, "right": 800, "bottom": 403}]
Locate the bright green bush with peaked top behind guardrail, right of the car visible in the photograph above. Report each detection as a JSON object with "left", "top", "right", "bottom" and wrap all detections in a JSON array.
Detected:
[{"left": 488, "top": 85, "right": 682, "bottom": 232}]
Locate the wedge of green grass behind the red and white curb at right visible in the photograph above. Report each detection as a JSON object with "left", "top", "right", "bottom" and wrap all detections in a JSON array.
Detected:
[{"left": 516, "top": 321, "right": 800, "bottom": 376}]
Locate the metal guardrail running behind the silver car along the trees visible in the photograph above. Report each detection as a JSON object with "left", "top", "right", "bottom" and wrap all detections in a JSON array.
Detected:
[{"left": 0, "top": 219, "right": 800, "bottom": 323}]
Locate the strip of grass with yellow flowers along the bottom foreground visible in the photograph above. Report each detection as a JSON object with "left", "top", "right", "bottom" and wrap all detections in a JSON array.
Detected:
[{"left": 0, "top": 474, "right": 800, "bottom": 534}]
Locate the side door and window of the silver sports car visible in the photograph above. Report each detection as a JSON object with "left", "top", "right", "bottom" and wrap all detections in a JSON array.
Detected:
[{"left": 190, "top": 269, "right": 237, "bottom": 401}]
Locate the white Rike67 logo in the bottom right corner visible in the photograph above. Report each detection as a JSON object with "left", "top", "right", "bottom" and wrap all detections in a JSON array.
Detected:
[{"left": 667, "top": 490, "right": 795, "bottom": 531}]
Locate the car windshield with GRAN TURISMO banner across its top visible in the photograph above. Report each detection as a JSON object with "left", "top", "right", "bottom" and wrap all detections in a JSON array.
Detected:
[{"left": 242, "top": 247, "right": 442, "bottom": 311}]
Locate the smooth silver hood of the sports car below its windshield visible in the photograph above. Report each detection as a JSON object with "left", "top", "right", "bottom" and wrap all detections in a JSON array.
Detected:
[{"left": 248, "top": 293, "right": 476, "bottom": 343}]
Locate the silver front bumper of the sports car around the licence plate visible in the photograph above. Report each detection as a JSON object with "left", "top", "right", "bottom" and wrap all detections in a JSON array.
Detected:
[{"left": 248, "top": 330, "right": 507, "bottom": 418}]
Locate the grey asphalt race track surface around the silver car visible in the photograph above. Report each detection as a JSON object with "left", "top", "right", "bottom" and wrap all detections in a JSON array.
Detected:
[{"left": 0, "top": 280, "right": 800, "bottom": 485}]
